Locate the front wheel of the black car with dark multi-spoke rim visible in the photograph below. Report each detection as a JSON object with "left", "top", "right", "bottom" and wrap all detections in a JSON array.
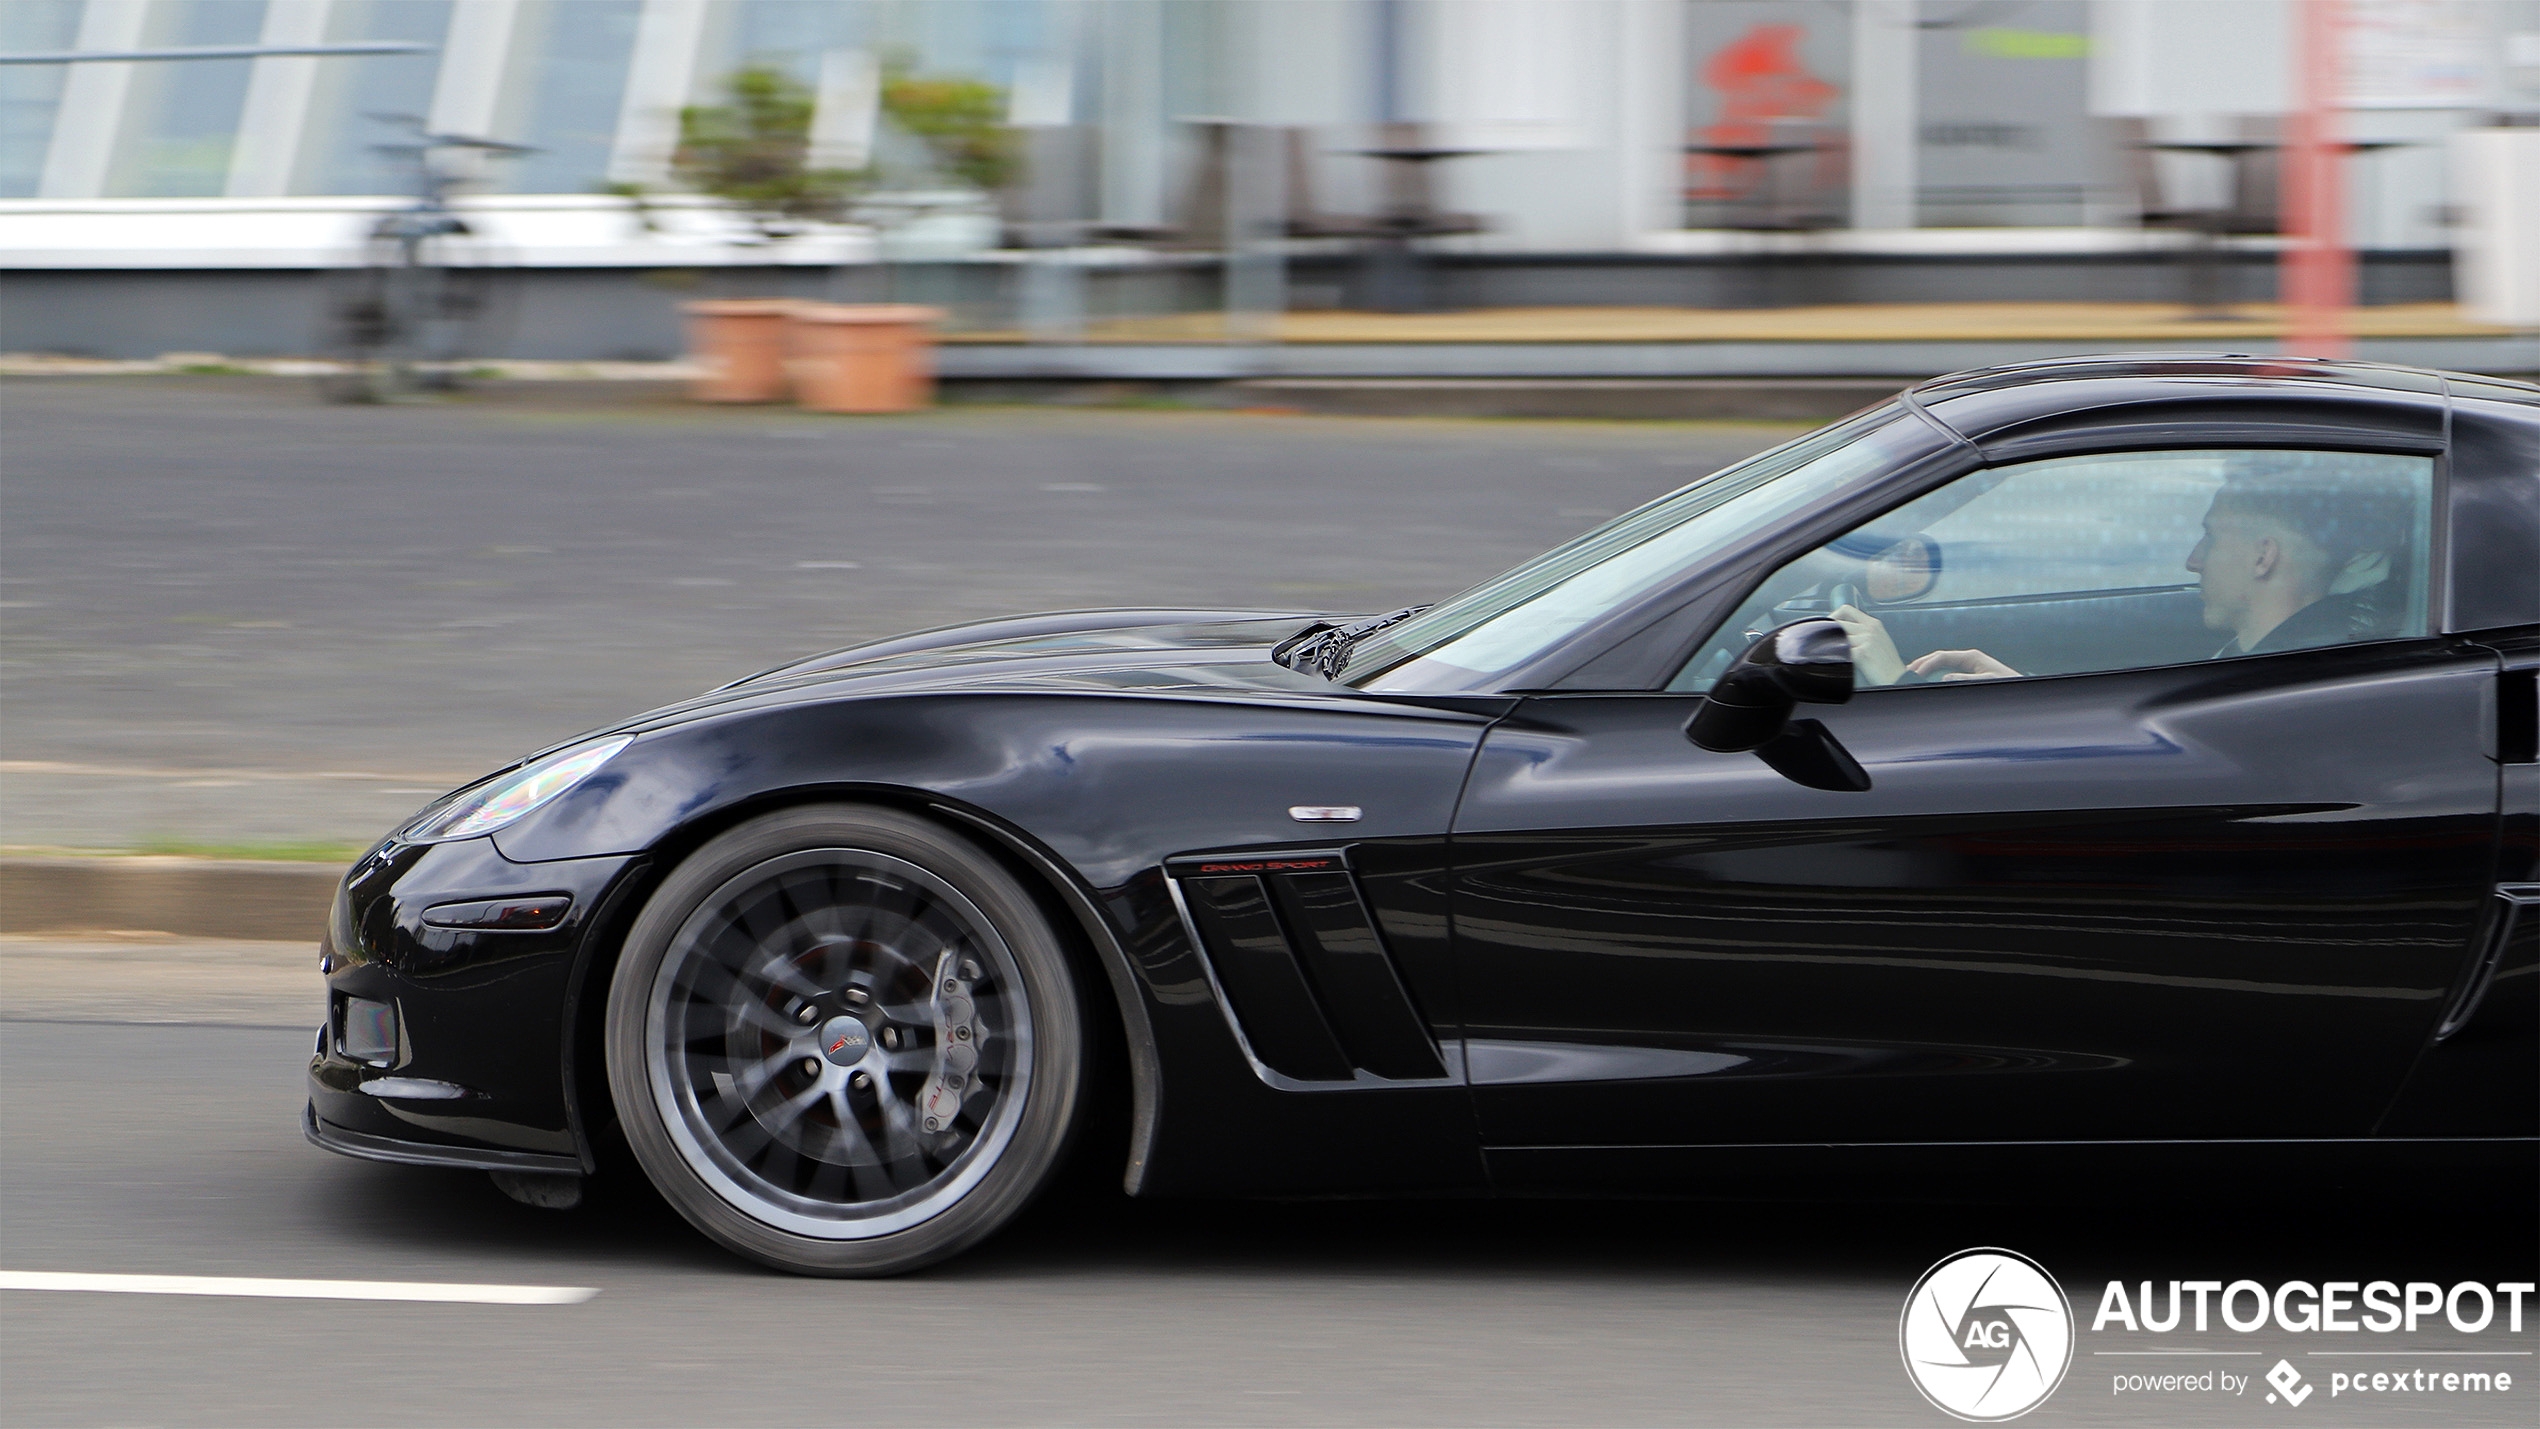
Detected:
[{"left": 605, "top": 805, "right": 1087, "bottom": 1277}]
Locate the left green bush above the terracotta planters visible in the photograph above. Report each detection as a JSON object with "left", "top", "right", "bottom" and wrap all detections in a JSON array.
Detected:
[{"left": 671, "top": 63, "right": 866, "bottom": 239}]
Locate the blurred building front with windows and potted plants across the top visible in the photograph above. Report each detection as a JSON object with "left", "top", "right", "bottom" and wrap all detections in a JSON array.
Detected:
[{"left": 0, "top": 0, "right": 2540, "bottom": 381}]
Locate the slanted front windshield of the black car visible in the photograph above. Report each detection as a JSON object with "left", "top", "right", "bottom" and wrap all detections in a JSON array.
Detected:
[{"left": 1346, "top": 406, "right": 1933, "bottom": 693}]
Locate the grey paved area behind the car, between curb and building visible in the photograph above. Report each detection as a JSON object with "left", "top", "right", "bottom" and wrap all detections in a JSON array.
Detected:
[{"left": 0, "top": 378, "right": 1796, "bottom": 848}]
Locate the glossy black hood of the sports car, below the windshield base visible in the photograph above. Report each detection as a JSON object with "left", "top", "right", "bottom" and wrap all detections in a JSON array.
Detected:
[{"left": 596, "top": 612, "right": 1359, "bottom": 731}]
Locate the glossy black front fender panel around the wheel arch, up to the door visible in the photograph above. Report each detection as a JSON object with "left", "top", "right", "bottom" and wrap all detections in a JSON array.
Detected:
[{"left": 317, "top": 668, "right": 1488, "bottom": 1193}]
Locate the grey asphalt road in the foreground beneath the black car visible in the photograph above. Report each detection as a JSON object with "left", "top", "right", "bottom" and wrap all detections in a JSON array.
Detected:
[{"left": 0, "top": 1005, "right": 2540, "bottom": 1426}]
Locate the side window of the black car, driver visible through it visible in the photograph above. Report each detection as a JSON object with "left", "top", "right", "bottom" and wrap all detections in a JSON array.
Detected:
[{"left": 1669, "top": 449, "right": 2433, "bottom": 693}]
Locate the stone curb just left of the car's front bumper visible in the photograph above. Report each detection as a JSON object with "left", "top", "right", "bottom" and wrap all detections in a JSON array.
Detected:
[{"left": 0, "top": 855, "right": 343, "bottom": 942}]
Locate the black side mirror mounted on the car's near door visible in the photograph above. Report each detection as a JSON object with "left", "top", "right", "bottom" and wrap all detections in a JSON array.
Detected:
[{"left": 1684, "top": 619, "right": 1869, "bottom": 794}]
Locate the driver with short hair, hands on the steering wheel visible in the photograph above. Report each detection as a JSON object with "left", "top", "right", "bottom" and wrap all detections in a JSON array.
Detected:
[{"left": 1834, "top": 454, "right": 2405, "bottom": 685}]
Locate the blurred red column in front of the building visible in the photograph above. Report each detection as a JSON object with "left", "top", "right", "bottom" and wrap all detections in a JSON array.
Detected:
[{"left": 2278, "top": 0, "right": 2355, "bottom": 358}]
